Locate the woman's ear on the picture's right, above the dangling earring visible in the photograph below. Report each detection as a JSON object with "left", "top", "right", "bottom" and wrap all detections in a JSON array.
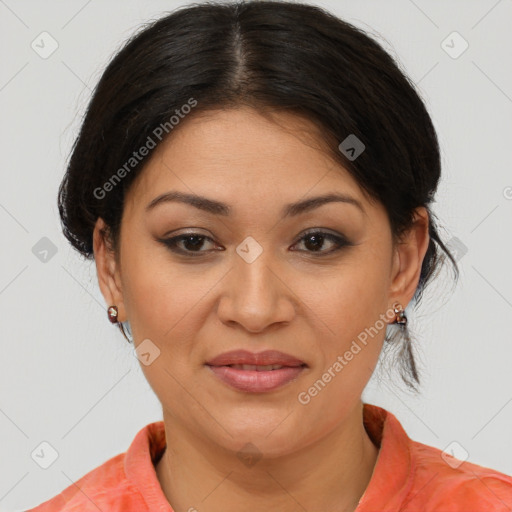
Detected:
[{"left": 389, "top": 206, "right": 430, "bottom": 309}]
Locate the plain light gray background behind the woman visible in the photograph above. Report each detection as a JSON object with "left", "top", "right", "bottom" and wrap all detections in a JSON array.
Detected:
[{"left": 0, "top": 0, "right": 512, "bottom": 511}]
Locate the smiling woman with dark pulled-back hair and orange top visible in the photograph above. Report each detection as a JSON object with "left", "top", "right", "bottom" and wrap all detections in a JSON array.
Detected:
[{"left": 28, "top": 1, "right": 512, "bottom": 512}]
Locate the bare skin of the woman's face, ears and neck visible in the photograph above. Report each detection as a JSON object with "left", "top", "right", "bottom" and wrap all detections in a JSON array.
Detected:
[{"left": 94, "top": 107, "right": 429, "bottom": 512}]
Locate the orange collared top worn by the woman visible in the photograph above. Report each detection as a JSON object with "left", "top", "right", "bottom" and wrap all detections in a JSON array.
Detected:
[{"left": 27, "top": 403, "right": 512, "bottom": 512}]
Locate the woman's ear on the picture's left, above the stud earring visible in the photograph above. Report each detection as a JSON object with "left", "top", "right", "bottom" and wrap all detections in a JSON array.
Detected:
[{"left": 93, "top": 217, "right": 127, "bottom": 322}]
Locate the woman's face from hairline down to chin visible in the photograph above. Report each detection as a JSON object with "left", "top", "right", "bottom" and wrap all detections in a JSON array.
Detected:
[{"left": 94, "top": 108, "right": 427, "bottom": 456}]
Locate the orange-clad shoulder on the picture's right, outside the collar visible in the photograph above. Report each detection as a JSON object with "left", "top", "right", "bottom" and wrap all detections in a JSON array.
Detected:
[{"left": 403, "top": 441, "right": 512, "bottom": 512}]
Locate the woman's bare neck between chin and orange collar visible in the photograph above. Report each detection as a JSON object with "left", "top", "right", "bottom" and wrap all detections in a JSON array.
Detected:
[{"left": 156, "top": 402, "right": 378, "bottom": 512}]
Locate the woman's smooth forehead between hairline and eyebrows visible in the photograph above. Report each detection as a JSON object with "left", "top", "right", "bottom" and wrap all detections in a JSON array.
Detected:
[{"left": 127, "top": 107, "right": 361, "bottom": 196}]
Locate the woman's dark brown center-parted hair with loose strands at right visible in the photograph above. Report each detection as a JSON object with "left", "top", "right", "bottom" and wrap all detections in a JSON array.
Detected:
[{"left": 58, "top": 0, "right": 458, "bottom": 389}]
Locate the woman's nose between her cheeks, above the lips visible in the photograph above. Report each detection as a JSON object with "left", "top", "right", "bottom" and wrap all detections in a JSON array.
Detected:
[{"left": 217, "top": 251, "right": 298, "bottom": 333}]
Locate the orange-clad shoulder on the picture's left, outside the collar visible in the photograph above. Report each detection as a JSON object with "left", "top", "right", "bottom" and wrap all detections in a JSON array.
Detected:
[{"left": 26, "top": 453, "right": 145, "bottom": 512}]
